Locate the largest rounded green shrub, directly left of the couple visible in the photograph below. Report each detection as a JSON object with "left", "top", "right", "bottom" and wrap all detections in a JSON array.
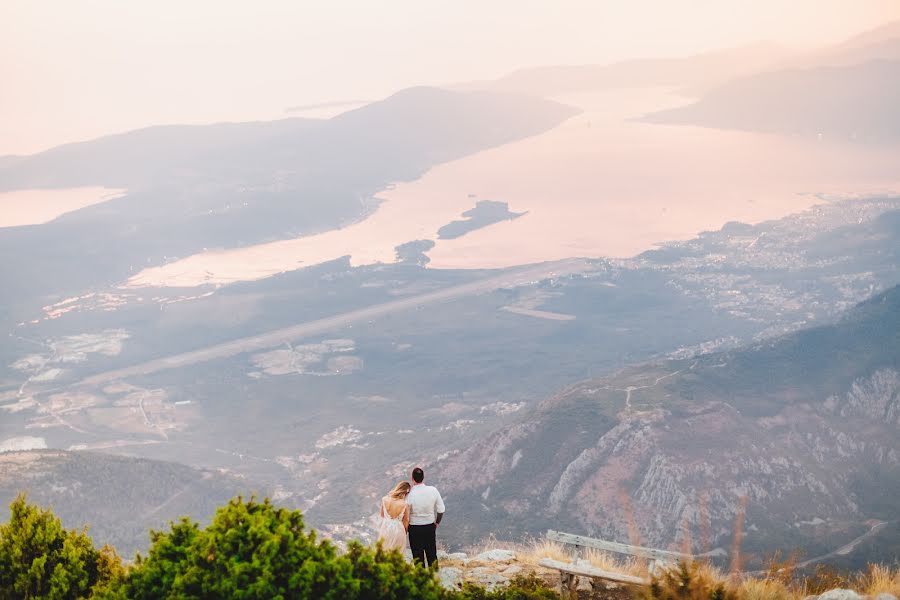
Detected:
[{"left": 124, "top": 498, "right": 446, "bottom": 600}]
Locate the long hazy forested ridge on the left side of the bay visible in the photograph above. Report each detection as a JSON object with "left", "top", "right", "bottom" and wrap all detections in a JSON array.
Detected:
[{"left": 0, "top": 87, "right": 577, "bottom": 319}]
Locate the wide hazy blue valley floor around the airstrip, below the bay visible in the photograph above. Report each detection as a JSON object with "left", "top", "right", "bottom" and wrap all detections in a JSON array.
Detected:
[{"left": 0, "top": 198, "right": 900, "bottom": 543}]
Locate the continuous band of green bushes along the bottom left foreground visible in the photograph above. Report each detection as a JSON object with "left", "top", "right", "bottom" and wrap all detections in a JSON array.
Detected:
[{"left": 0, "top": 496, "right": 557, "bottom": 600}]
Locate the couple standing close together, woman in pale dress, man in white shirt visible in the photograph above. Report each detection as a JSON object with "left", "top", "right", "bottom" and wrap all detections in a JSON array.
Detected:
[{"left": 378, "top": 467, "right": 444, "bottom": 568}]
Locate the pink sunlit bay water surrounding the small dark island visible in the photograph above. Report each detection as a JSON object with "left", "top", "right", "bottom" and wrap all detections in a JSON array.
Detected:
[{"left": 129, "top": 89, "right": 900, "bottom": 286}]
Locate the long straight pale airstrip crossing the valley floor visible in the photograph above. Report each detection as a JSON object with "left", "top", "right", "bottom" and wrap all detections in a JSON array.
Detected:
[{"left": 79, "top": 259, "right": 592, "bottom": 386}]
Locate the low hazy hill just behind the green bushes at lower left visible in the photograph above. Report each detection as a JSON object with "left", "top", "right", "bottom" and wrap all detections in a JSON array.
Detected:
[{"left": 0, "top": 450, "right": 268, "bottom": 559}]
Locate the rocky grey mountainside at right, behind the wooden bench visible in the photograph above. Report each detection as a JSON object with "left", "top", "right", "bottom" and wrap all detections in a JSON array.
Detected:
[{"left": 442, "top": 288, "right": 900, "bottom": 552}]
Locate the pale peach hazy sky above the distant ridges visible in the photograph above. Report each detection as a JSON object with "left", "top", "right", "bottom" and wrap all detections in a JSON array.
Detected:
[{"left": 0, "top": 0, "right": 900, "bottom": 155}]
